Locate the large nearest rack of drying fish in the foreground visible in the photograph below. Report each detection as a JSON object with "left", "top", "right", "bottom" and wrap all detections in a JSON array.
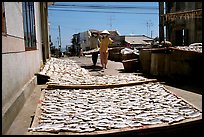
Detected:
[{"left": 29, "top": 83, "right": 202, "bottom": 133}]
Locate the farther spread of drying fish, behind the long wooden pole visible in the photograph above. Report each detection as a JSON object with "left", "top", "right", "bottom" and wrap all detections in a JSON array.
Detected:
[{"left": 40, "top": 58, "right": 146, "bottom": 85}]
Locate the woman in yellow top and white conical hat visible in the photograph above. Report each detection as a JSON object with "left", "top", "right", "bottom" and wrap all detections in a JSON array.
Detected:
[{"left": 100, "top": 30, "right": 113, "bottom": 69}]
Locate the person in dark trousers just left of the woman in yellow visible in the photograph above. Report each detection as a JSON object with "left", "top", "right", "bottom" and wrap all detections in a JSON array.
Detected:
[{"left": 90, "top": 31, "right": 100, "bottom": 66}]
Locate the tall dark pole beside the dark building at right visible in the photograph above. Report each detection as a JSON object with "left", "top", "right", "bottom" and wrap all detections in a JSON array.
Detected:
[{"left": 159, "top": 2, "right": 164, "bottom": 44}]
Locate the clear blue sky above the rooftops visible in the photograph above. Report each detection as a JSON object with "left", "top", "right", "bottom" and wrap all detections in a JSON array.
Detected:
[{"left": 48, "top": 2, "right": 159, "bottom": 48}]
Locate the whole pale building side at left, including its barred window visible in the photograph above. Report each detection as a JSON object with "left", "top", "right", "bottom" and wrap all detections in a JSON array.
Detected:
[{"left": 2, "top": 2, "right": 50, "bottom": 134}]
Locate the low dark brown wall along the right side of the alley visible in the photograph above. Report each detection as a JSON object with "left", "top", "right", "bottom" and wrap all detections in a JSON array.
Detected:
[{"left": 139, "top": 48, "right": 203, "bottom": 82}]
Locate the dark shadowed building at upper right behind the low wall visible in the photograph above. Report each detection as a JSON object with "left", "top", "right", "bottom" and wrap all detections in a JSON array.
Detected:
[{"left": 165, "top": 2, "right": 202, "bottom": 46}]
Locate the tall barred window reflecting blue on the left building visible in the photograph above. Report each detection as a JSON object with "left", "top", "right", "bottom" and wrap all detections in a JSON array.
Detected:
[{"left": 22, "top": 2, "right": 36, "bottom": 50}]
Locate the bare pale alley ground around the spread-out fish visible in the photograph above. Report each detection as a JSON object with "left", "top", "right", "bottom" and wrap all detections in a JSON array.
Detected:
[{"left": 6, "top": 56, "right": 202, "bottom": 135}]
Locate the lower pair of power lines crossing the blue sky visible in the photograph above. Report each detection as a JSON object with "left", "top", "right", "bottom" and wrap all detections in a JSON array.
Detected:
[{"left": 48, "top": 8, "right": 159, "bottom": 14}]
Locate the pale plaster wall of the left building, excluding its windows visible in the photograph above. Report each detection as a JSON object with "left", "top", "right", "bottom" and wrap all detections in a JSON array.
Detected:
[{"left": 2, "top": 2, "right": 43, "bottom": 134}]
